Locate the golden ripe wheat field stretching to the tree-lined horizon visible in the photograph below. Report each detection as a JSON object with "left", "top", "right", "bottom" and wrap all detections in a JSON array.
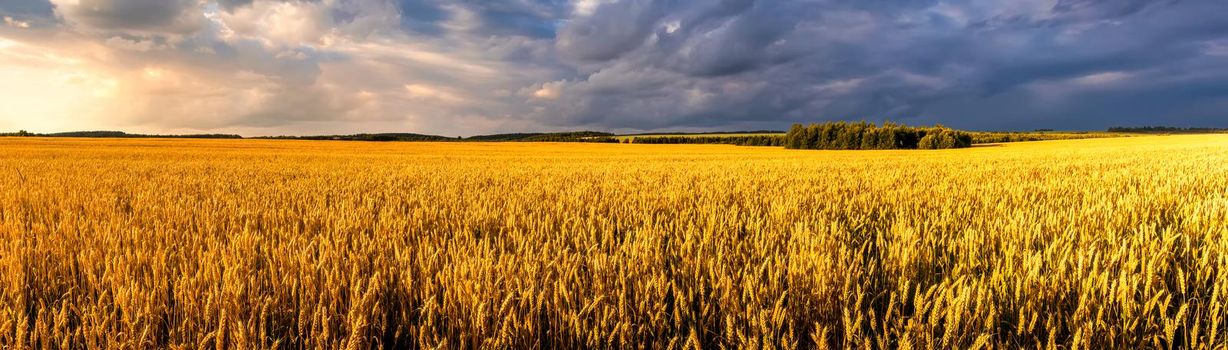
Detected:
[{"left": 0, "top": 135, "right": 1228, "bottom": 349}]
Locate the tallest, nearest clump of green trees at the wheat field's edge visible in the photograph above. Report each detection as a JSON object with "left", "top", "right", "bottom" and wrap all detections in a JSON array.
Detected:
[{"left": 785, "top": 122, "right": 973, "bottom": 150}]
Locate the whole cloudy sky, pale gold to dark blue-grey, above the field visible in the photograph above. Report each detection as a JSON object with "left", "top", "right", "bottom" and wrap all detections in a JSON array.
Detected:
[{"left": 0, "top": 0, "right": 1228, "bottom": 136}]
